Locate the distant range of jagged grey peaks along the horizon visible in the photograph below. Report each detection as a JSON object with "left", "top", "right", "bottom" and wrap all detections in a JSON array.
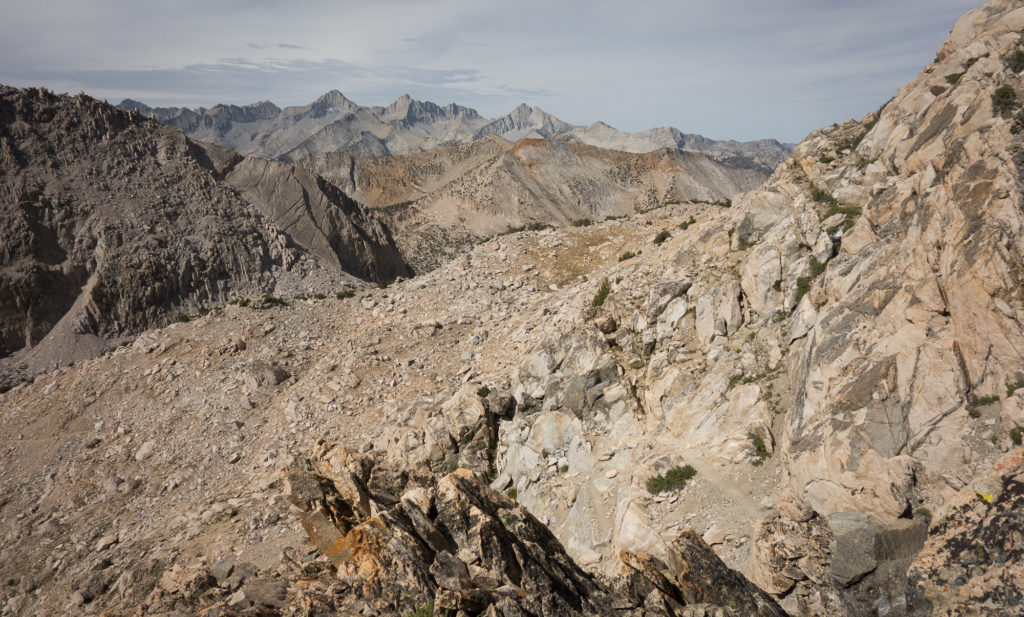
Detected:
[{"left": 118, "top": 90, "right": 793, "bottom": 174}]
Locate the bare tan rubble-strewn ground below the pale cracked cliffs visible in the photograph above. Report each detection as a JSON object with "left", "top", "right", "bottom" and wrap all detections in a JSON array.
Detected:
[{"left": 0, "top": 205, "right": 774, "bottom": 612}]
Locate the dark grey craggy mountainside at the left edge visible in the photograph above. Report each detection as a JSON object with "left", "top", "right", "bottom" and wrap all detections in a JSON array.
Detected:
[{"left": 0, "top": 87, "right": 410, "bottom": 380}]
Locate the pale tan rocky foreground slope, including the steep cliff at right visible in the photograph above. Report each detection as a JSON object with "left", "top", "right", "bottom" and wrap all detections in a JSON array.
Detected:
[{"left": 6, "top": 0, "right": 1024, "bottom": 617}]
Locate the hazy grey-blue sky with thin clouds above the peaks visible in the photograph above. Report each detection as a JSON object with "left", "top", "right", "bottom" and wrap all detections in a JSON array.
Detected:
[{"left": 0, "top": 0, "right": 981, "bottom": 142}]
